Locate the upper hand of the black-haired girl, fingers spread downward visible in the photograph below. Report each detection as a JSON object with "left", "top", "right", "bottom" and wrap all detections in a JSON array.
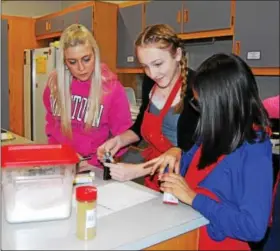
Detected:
[{"left": 151, "top": 147, "right": 182, "bottom": 179}]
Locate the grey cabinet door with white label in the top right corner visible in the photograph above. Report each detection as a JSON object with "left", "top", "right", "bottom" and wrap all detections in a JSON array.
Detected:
[{"left": 235, "top": 1, "right": 280, "bottom": 67}]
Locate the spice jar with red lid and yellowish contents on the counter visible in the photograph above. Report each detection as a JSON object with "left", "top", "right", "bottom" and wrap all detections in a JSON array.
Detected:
[{"left": 76, "top": 186, "right": 97, "bottom": 240}]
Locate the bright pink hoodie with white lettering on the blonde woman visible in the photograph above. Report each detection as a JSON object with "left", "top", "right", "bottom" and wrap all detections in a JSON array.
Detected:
[{"left": 43, "top": 64, "right": 132, "bottom": 166}]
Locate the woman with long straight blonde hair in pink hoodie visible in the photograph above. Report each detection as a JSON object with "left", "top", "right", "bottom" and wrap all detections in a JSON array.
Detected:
[{"left": 43, "top": 24, "right": 132, "bottom": 169}]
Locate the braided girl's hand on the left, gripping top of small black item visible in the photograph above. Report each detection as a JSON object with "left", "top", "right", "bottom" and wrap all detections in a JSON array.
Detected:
[{"left": 97, "top": 136, "right": 121, "bottom": 162}]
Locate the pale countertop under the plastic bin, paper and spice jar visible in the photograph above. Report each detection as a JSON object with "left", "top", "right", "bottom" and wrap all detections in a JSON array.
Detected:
[{"left": 2, "top": 132, "right": 208, "bottom": 250}]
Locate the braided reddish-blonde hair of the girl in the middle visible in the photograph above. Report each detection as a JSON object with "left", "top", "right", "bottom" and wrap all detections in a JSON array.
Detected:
[{"left": 135, "top": 24, "right": 188, "bottom": 113}]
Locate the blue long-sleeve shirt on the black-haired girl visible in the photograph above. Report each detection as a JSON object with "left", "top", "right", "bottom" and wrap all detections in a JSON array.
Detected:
[{"left": 181, "top": 139, "right": 273, "bottom": 241}]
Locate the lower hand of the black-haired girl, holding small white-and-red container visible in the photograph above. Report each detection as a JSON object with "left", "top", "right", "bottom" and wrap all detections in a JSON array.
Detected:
[{"left": 160, "top": 173, "right": 196, "bottom": 206}]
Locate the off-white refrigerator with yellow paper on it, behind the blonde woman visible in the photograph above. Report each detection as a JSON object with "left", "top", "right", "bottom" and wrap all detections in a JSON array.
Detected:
[{"left": 24, "top": 47, "right": 58, "bottom": 143}]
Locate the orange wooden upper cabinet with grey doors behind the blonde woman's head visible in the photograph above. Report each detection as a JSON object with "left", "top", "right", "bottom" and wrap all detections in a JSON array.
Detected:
[{"left": 35, "top": 1, "right": 118, "bottom": 72}]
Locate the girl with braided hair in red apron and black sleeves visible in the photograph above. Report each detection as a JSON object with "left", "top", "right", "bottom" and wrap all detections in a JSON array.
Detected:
[{"left": 97, "top": 24, "right": 199, "bottom": 190}]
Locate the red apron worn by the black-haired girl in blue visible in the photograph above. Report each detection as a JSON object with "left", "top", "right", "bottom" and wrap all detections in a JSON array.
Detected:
[{"left": 185, "top": 147, "right": 250, "bottom": 250}]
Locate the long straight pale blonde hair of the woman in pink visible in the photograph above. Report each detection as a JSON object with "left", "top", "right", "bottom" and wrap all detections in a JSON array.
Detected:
[{"left": 51, "top": 24, "right": 102, "bottom": 136}]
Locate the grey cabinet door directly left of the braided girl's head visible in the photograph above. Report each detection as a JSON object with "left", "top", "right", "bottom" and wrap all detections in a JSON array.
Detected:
[{"left": 117, "top": 4, "right": 142, "bottom": 68}]
